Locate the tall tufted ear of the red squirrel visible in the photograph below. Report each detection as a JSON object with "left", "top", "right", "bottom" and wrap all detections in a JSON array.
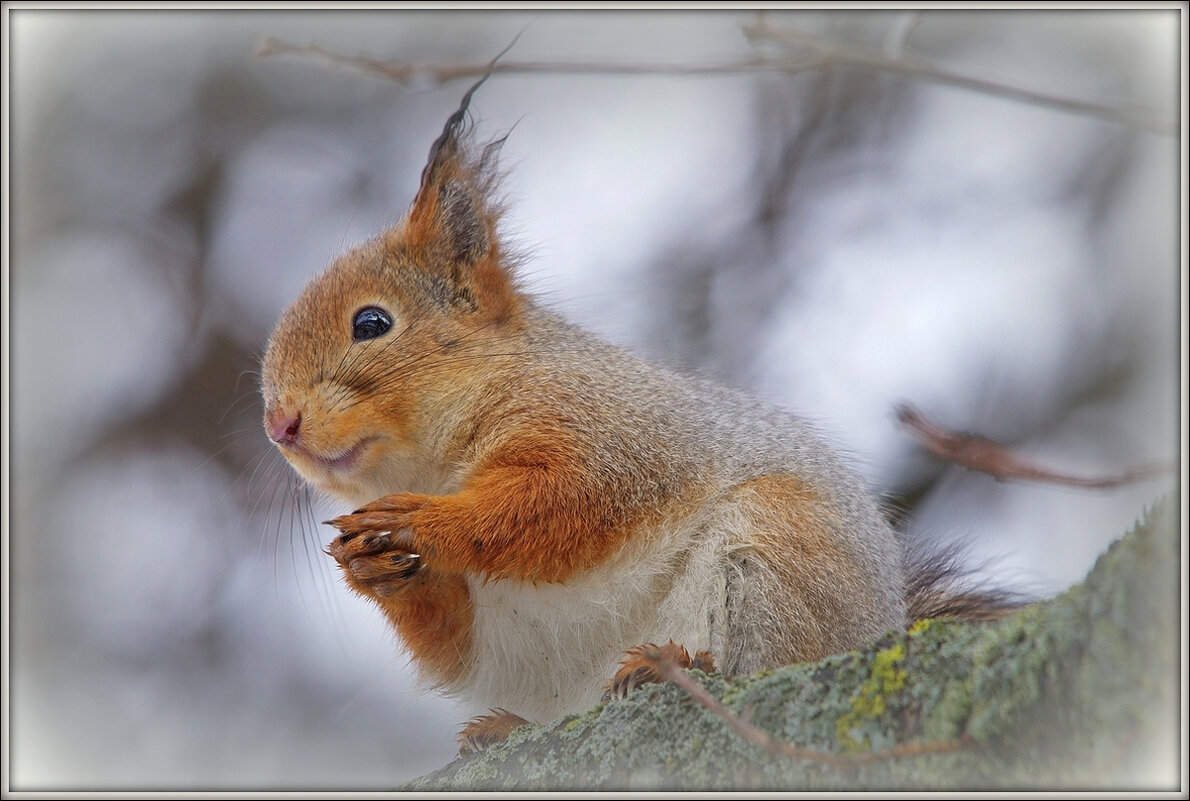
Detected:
[{"left": 403, "top": 75, "right": 503, "bottom": 269}]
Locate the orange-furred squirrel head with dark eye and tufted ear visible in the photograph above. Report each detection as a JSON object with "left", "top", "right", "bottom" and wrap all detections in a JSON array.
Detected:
[{"left": 261, "top": 74, "right": 522, "bottom": 500}]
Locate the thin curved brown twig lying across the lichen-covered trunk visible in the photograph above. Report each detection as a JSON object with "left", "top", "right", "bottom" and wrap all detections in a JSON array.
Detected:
[{"left": 640, "top": 647, "right": 971, "bottom": 765}]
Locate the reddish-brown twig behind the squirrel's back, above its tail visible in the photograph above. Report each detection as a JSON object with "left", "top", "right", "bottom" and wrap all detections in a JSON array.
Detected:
[{"left": 896, "top": 403, "right": 1175, "bottom": 489}]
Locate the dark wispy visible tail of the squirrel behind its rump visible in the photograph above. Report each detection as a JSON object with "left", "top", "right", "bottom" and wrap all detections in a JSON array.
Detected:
[{"left": 904, "top": 537, "right": 1029, "bottom": 624}]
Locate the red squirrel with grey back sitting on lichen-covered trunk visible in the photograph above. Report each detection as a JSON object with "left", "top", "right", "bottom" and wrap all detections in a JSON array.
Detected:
[{"left": 262, "top": 76, "right": 1012, "bottom": 753}]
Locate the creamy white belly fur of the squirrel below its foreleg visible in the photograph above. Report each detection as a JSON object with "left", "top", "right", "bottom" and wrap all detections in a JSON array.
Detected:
[{"left": 458, "top": 516, "right": 726, "bottom": 722}]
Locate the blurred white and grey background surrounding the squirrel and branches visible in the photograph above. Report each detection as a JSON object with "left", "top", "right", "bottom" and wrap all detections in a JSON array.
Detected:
[{"left": 6, "top": 8, "right": 1182, "bottom": 790}]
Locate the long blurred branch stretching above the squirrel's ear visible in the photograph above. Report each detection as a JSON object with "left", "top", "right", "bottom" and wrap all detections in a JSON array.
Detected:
[{"left": 257, "top": 15, "right": 1178, "bottom": 136}]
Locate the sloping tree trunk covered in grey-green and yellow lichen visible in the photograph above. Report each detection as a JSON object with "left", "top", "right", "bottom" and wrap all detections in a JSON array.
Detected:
[{"left": 401, "top": 496, "right": 1182, "bottom": 790}]
